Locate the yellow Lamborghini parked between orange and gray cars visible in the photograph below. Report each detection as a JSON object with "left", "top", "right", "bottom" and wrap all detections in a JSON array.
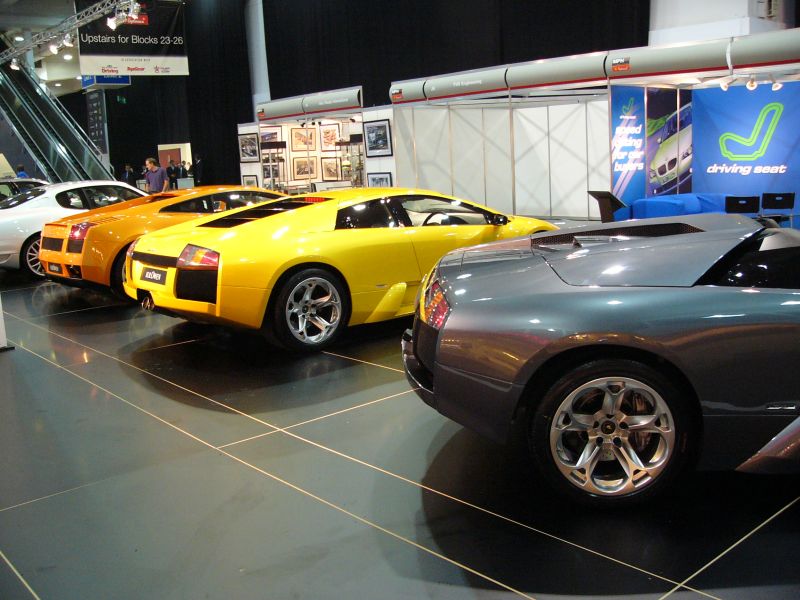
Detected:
[{"left": 124, "top": 188, "right": 556, "bottom": 350}]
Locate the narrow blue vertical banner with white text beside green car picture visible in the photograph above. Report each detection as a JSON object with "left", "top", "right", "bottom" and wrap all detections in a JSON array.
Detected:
[{"left": 611, "top": 86, "right": 646, "bottom": 205}]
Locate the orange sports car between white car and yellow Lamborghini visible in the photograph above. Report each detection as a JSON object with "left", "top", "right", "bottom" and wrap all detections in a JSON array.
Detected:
[{"left": 39, "top": 185, "right": 284, "bottom": 297}]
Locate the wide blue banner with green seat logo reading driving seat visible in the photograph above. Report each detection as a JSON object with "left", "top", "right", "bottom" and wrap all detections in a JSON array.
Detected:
[{"left": 692, "top": 83, "right": 800, "bottom": 196}]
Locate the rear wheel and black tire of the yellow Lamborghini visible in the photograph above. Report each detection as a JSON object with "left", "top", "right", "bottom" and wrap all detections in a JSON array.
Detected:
[{"left": 265, "top": 268, "right": 350, "bottom": 352}]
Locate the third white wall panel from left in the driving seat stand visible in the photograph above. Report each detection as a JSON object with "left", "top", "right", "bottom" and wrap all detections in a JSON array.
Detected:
[{"left": 450, "top": 108, "right": 486, "bottom": 204}]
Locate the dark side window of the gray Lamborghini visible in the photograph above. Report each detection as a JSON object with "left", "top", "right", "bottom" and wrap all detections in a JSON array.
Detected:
[{"left": 703, "top": 229, "right": 800, "bottom": 289}]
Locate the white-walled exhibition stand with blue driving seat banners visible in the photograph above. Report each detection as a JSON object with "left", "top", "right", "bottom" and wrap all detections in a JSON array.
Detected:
[{"left": 390, "top": 29, "right": 800, "bottom": 218}]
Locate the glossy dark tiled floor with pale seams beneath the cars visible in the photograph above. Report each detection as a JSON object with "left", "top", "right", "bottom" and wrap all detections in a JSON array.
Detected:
[{"left": 0, "top": 272, "right": 800, "bottom": 600}]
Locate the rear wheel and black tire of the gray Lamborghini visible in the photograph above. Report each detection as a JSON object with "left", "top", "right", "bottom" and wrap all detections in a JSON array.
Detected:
[{"left": 528, "top": 359, "right": 699, "bottom": 507}]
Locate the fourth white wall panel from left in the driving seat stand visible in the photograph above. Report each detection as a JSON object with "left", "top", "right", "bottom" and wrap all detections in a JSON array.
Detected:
[{"left": 483, "top": 108, "right": 514, "bottom": 213}]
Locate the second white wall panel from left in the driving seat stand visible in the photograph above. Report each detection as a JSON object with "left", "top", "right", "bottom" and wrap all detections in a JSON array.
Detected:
[{"left": 414, "top": 106, "right": 452, "bottom": 193}]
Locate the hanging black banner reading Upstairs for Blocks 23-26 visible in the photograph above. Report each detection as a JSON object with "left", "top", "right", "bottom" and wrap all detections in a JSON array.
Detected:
[{"left": 76, "top": 0, "right": 189, "bottom": 76}]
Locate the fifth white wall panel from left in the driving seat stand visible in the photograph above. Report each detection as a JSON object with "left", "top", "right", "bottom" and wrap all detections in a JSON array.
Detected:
[{"left": 514, "top": 106, "right": 550, "bottom": 216}]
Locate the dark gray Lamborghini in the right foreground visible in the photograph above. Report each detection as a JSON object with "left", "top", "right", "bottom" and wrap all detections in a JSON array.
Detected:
[{"left": 403, "top": 214, "right": 800, "bottom": 505}]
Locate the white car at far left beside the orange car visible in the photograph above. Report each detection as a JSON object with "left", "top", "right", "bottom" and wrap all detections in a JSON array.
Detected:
[{"left": 0, "top": 180, "right": 145, "bottom": 277}]
